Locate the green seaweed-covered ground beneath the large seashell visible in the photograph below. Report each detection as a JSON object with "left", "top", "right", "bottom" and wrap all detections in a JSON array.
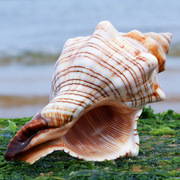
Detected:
[{"left": 0, "top": 107, "right": 180, "bottom": 180}]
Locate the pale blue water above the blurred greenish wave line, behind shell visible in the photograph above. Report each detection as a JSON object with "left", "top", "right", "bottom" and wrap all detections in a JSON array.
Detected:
[{"left": 0, "top": 0, "right": 180, "bottom": 53}]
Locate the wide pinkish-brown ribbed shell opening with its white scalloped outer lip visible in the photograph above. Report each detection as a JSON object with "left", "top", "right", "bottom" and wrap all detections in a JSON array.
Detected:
[{"left": 64, "top": 104, "right": 141, "bottom": 161}]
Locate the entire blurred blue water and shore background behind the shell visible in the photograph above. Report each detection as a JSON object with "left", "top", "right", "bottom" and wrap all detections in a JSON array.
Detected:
[{"left": 0, "top": 0, "right": 180, "bottom": 118}]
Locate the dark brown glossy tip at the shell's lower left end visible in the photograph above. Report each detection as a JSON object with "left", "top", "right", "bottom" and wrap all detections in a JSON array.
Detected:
[{"left": 4, "top": 114, "right": 48, "bottom": 161}]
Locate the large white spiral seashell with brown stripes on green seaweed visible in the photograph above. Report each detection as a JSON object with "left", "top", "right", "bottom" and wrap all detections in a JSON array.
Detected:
[{"left": 5, "top": 21, "right": 172, "bottom": 163}]
